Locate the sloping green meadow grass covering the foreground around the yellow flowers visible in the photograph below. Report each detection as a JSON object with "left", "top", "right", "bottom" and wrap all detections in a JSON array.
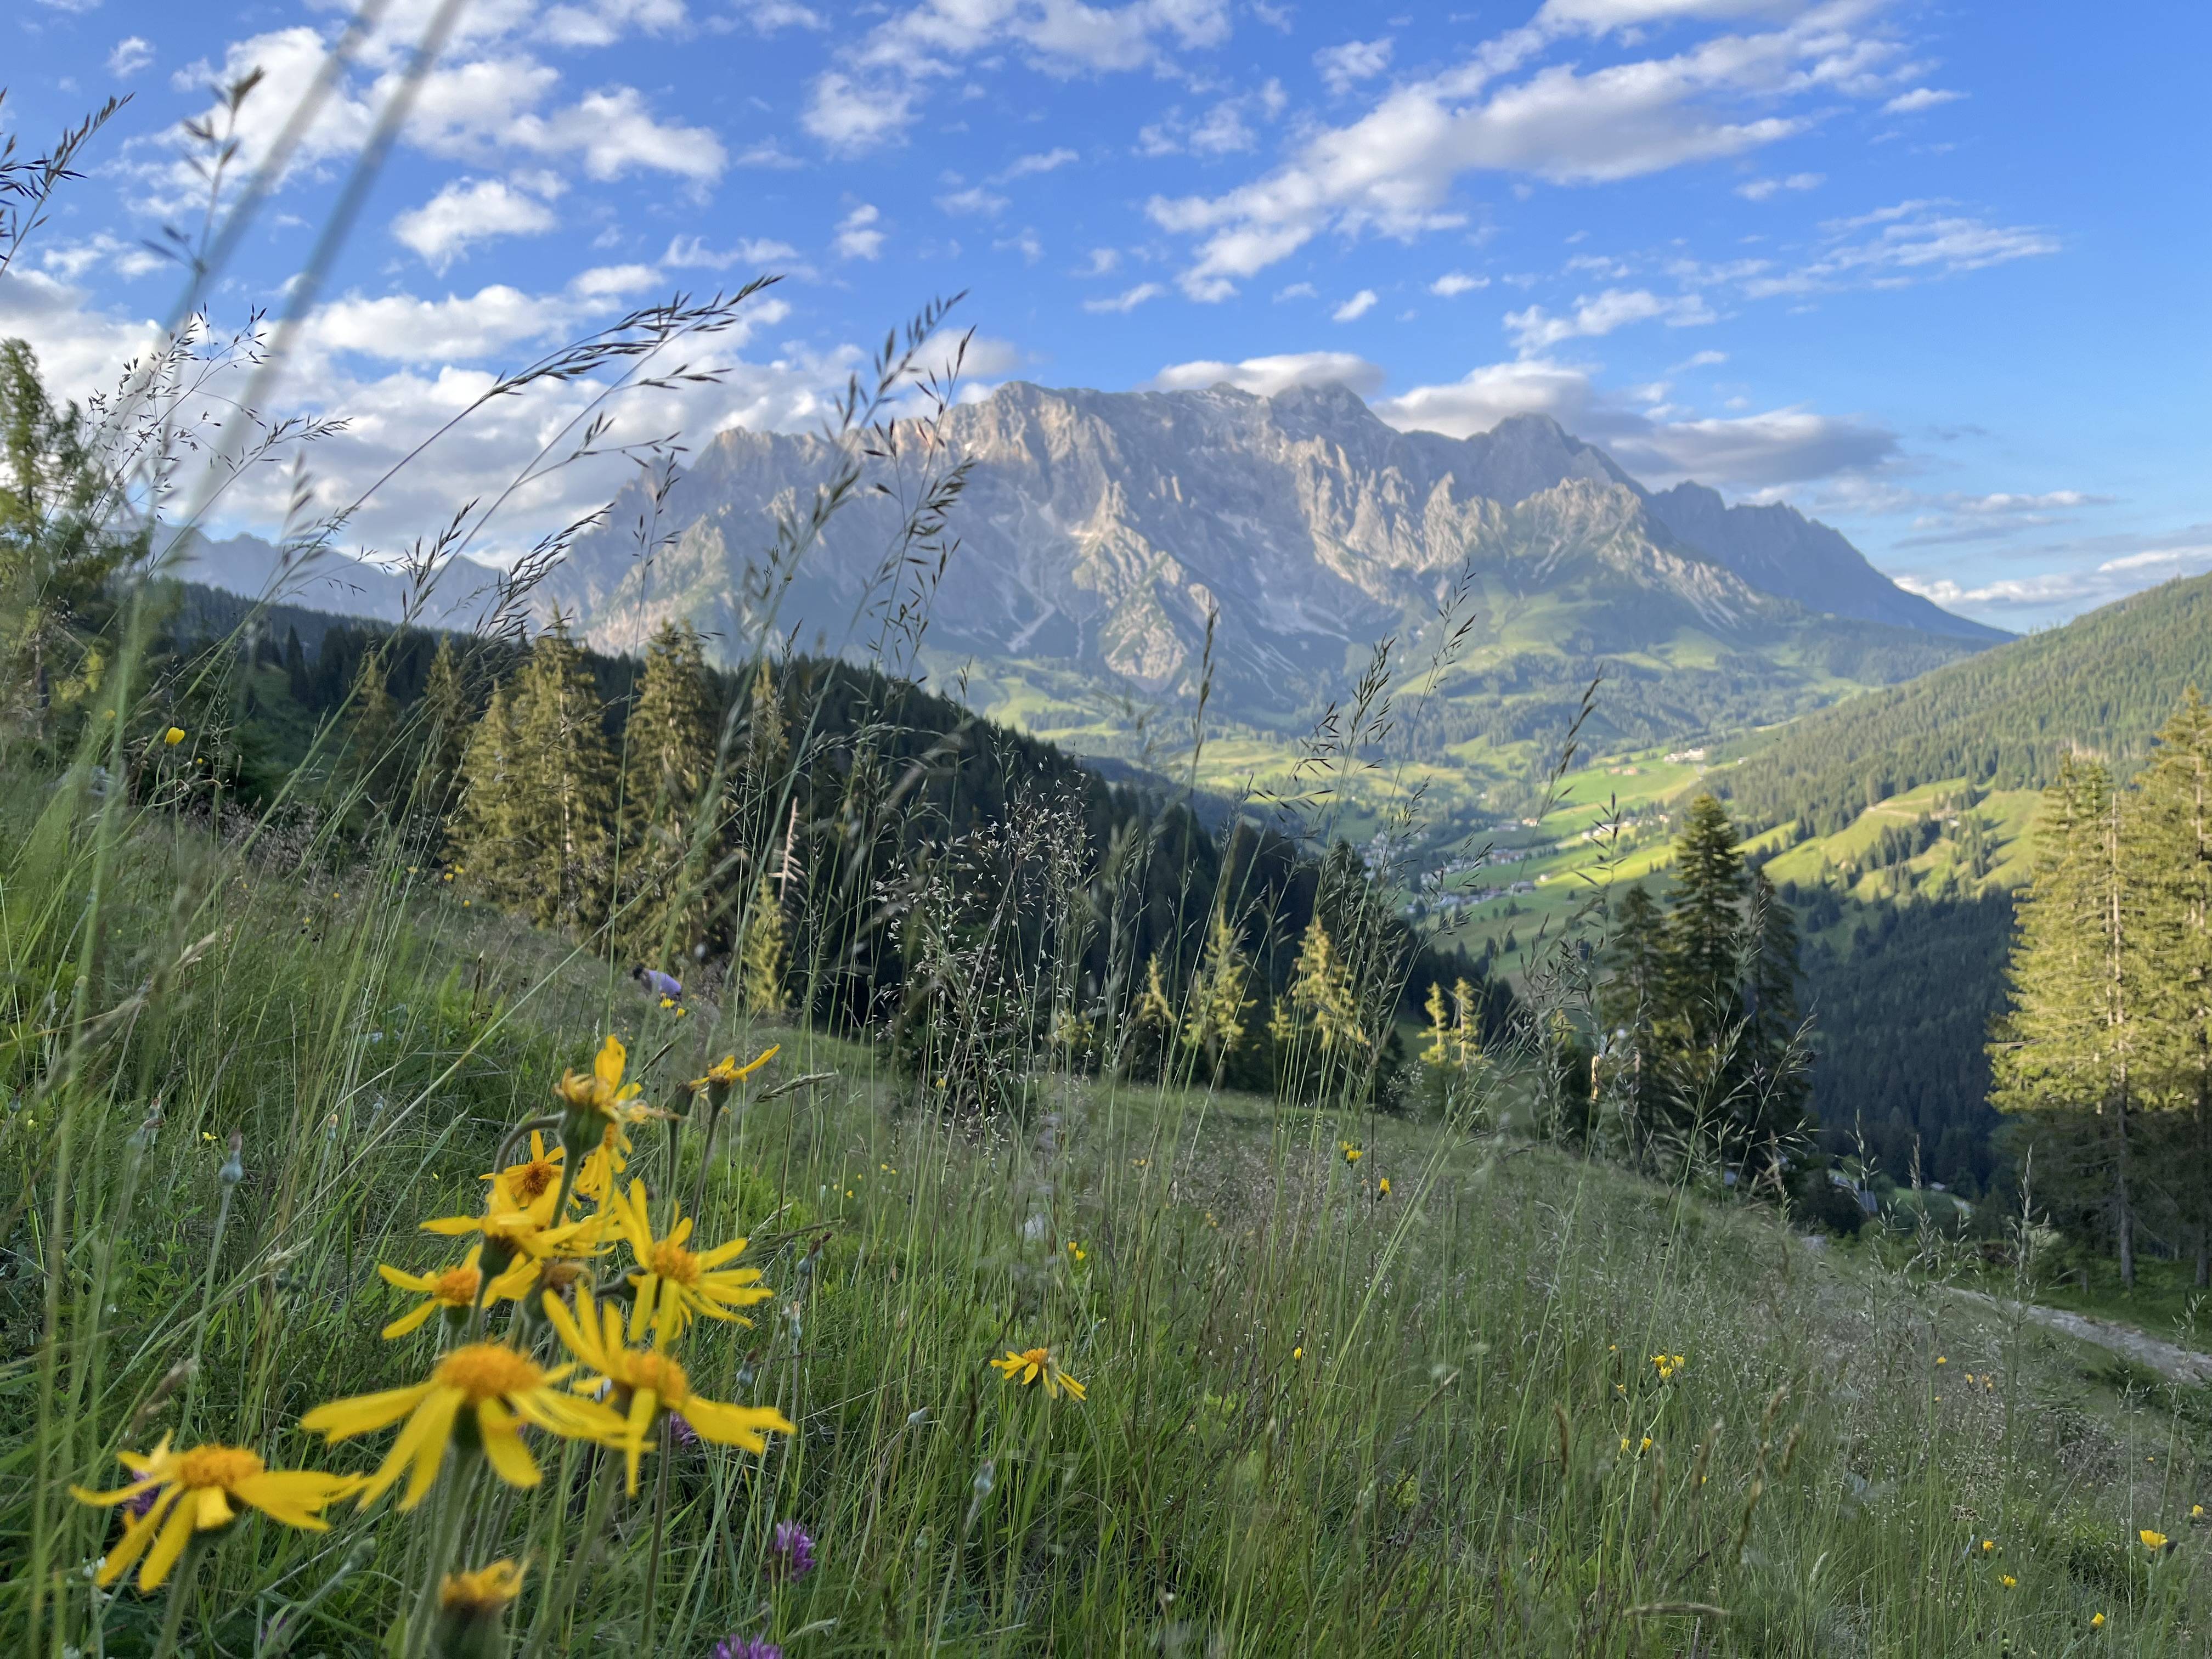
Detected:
[{"left": 13, "top": 776, "right": 2208, "bottom": 1655}]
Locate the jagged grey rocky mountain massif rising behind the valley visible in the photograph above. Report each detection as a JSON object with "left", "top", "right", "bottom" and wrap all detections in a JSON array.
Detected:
[{"left": 549, "top": 383, "right": 2002, "bottom": 723}]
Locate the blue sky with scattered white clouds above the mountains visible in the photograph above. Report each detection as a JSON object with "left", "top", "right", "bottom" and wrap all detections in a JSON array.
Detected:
[{"left": 0, "top": 0, "right": 2212, "bottom": 628}]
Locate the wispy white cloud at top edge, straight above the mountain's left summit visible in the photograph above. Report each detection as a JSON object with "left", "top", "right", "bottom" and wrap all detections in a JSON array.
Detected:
[{"left": 801, "top": 0, "right": 1230, "bottom": 153}]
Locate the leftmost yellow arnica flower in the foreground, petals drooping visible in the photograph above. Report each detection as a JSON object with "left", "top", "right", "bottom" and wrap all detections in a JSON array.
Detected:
[{"left": 69, "top": 1436, "right": 360, "bottom": 1590}]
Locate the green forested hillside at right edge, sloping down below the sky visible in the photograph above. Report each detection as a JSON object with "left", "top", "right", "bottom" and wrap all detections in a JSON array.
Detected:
[{"left": 1714, "top": 575, "right": 2212, "bottom": 836}]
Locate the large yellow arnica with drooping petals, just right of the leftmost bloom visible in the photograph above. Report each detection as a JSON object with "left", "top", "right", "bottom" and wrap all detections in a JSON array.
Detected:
[{"left": 298, "top": 1342, "right": 622, "bottom": 1509}]
